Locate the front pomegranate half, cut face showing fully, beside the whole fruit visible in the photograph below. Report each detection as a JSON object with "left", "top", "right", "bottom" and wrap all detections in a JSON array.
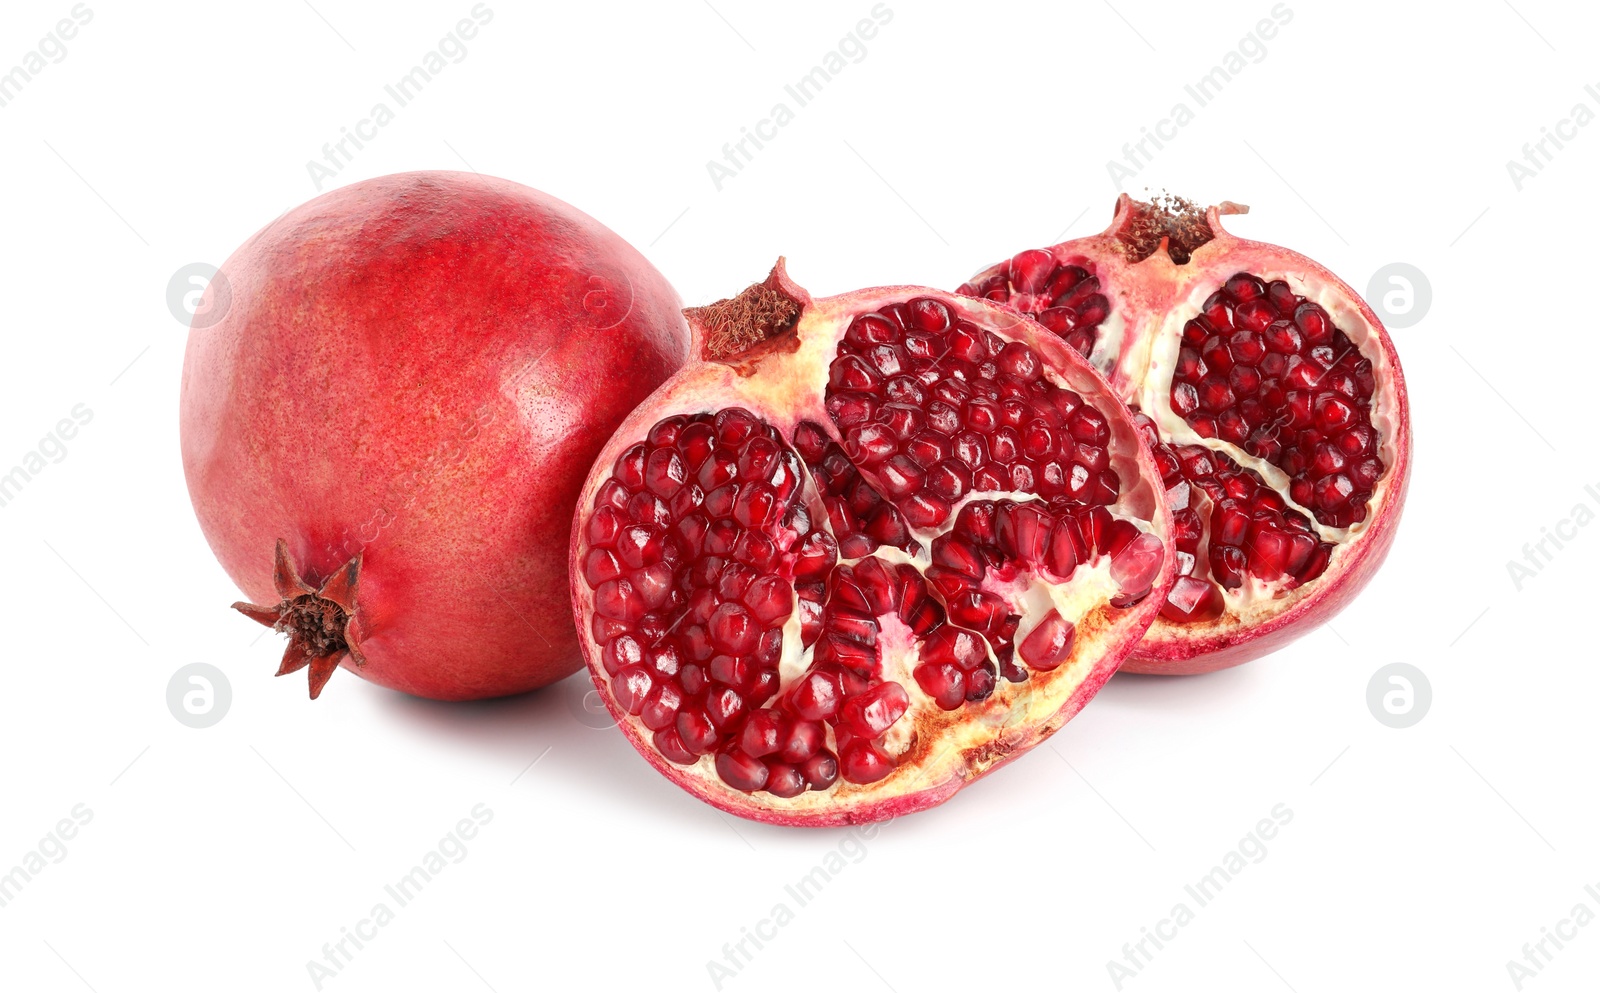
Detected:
[{"left": 571, "top": 261, "right": 1174, "bottom": 825}]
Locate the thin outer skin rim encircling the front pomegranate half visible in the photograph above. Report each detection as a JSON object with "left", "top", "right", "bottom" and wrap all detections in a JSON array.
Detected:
[{"left": 570, "top": 267, "right": 1176, "bottom": 827}]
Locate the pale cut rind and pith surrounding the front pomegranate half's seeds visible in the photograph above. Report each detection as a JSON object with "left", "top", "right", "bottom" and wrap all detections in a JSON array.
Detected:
[{"left": 570, "top": 264, "right": 1176, "bottom": 827}]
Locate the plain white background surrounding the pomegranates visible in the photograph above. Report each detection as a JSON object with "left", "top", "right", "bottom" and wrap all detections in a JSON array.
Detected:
[{"left": 0, "top": 0, "right": 1600, "bottom": 993}]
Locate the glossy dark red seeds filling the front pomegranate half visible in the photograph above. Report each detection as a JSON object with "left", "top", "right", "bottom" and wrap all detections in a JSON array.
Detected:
[{"left": 582, "top": 297, "right": 1162, "bottom": 798}]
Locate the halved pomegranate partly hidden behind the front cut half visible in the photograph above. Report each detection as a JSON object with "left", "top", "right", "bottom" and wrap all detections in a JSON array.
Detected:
[{"left": 958, "top": 195, "right": 1411, "bottom": 673}]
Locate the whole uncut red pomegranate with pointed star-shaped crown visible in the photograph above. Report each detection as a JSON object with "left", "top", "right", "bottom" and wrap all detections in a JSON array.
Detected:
[{"left": 181, "top": 173, "right": 688, "bottom": 700}]
